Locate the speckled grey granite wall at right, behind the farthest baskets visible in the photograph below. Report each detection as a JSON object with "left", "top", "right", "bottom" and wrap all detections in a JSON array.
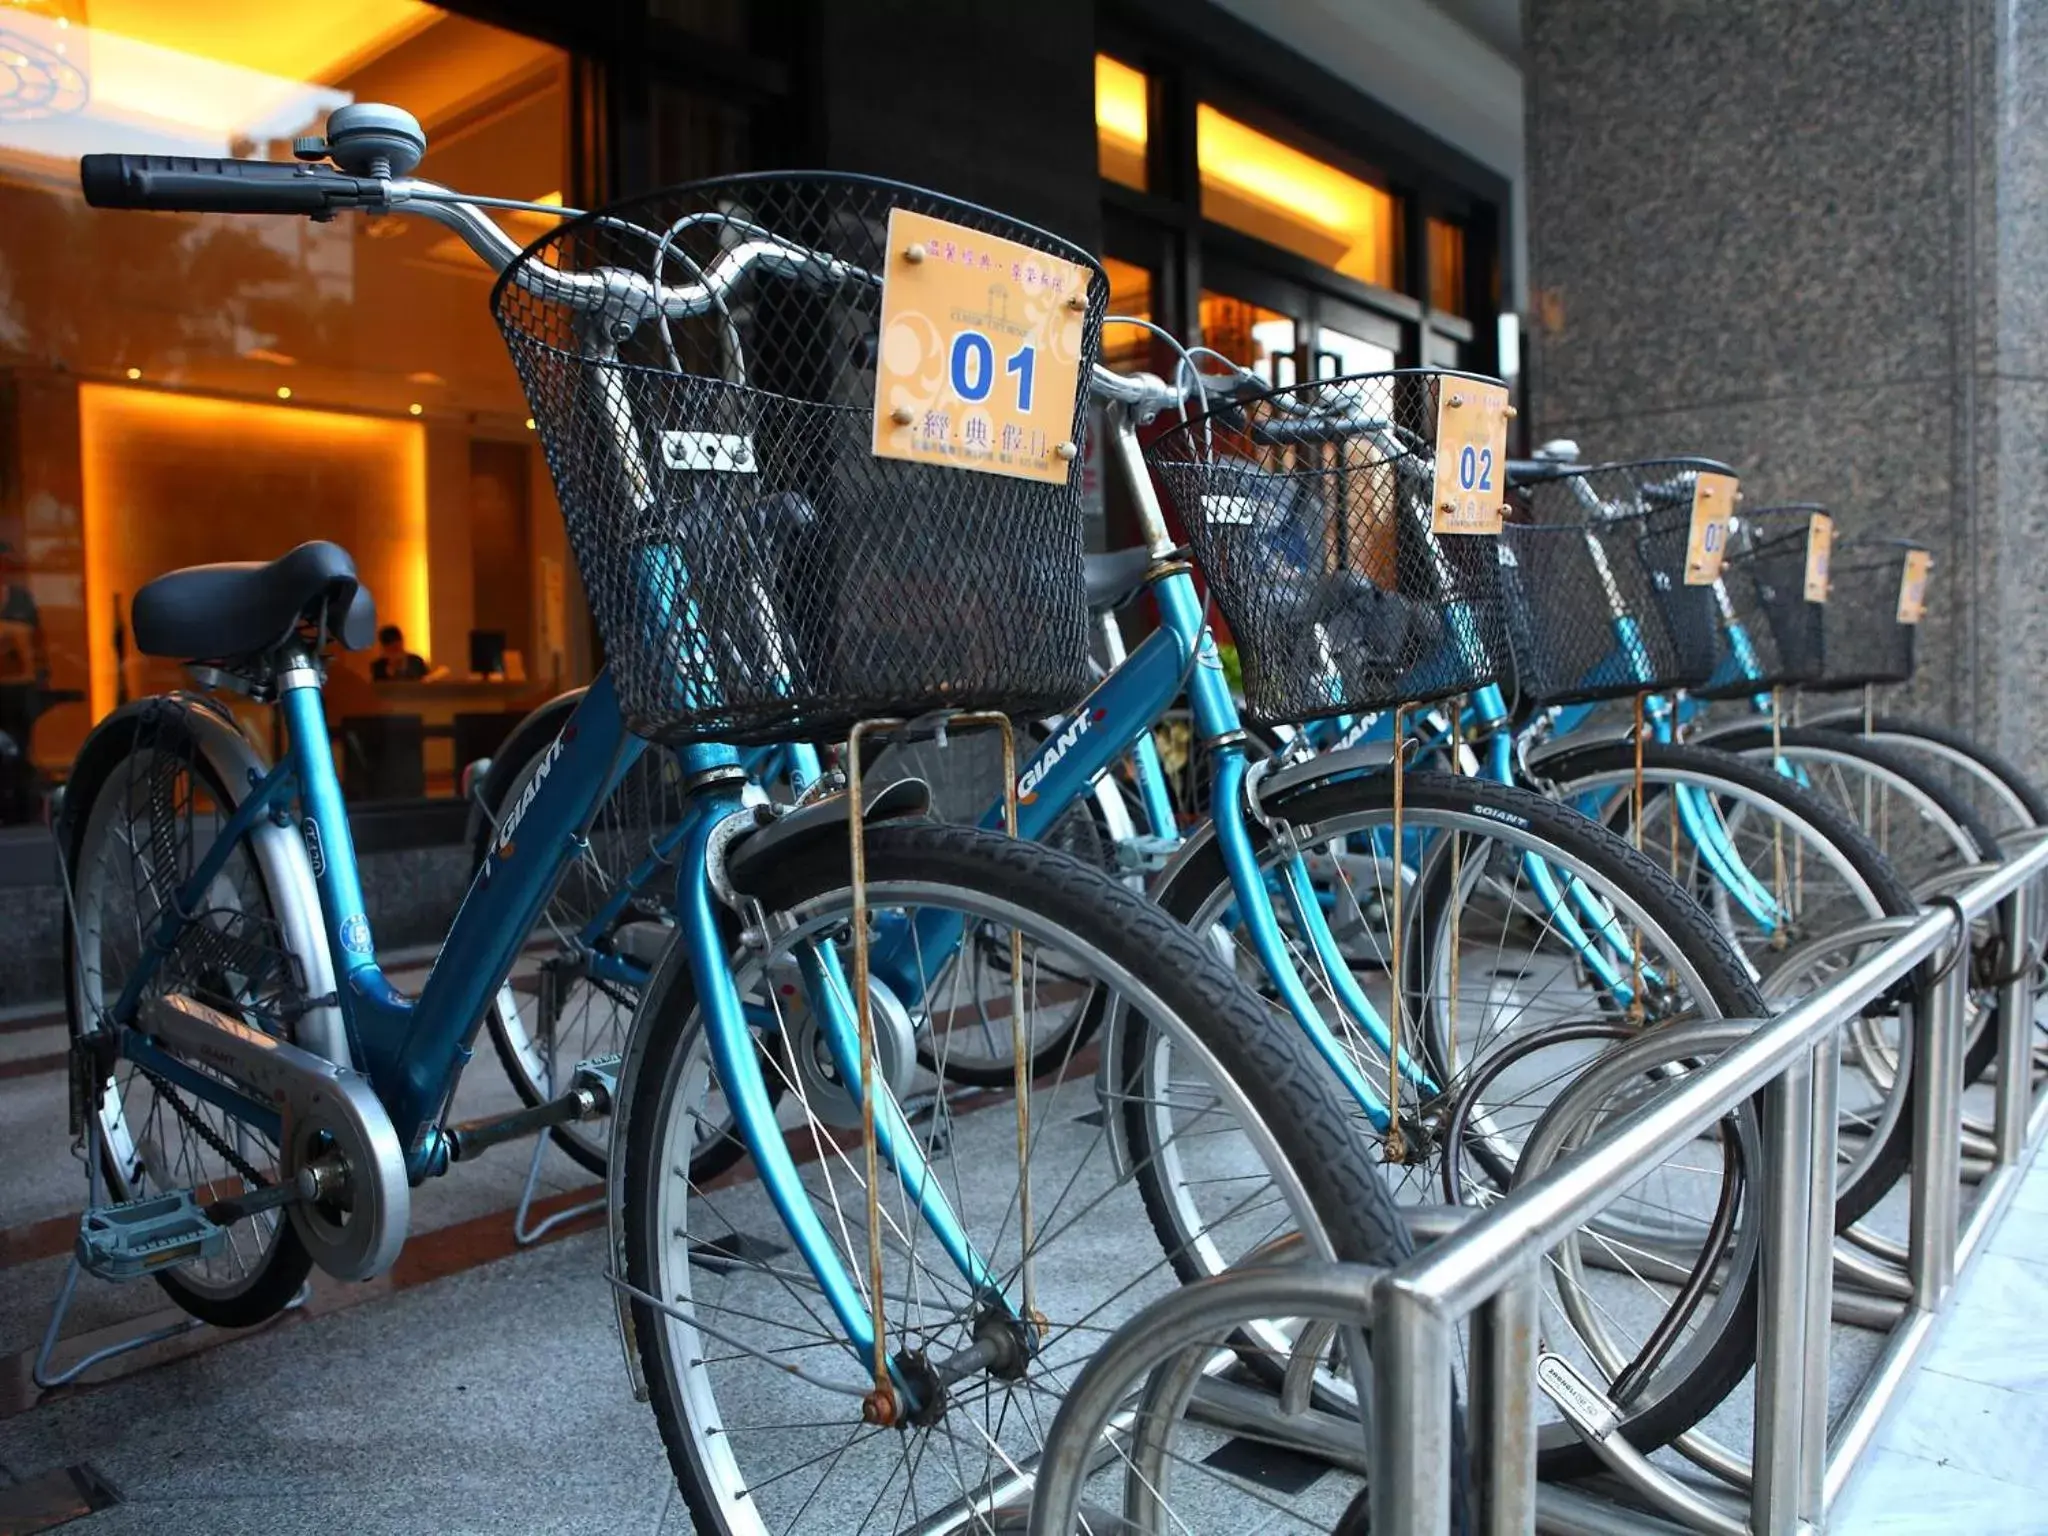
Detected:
[{"left": 1524, "top": 0, "right": 2048, "bottom": 768}]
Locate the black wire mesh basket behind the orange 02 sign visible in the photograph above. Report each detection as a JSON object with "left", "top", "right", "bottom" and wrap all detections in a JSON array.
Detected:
[{"left": 1145, "top": 369, "right": 1507, "bottom": 725}]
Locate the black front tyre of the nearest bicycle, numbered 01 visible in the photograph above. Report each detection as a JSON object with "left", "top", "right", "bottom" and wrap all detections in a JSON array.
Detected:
[{"left": 623, "top": 823, "right": 1433, "bottom": 1532}]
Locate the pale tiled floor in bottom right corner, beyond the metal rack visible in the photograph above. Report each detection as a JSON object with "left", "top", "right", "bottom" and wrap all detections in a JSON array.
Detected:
[{"left": 1829, "top": 1159, "right": 2048, "bottom": 1536}]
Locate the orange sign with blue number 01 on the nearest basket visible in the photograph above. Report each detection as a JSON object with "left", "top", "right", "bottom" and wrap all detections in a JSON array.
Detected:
[{"left": 874, "top": 209, "right": 1092, "bottom": 481}]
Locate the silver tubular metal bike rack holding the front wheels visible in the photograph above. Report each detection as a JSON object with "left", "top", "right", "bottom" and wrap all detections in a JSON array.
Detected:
[{"left": 1030, "top": 834, "right": 2048, "bottom": 1536}]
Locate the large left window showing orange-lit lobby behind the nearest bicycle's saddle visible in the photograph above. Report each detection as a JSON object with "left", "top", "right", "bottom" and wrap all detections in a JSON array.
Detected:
[{"left": 0, "top": 0, "right": 590, "bottom": 819}]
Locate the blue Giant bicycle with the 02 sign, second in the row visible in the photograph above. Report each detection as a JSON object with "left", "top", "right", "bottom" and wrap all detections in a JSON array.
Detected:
[{"left": 468, "top": 352, "right": 1794, "bottom": 1464}]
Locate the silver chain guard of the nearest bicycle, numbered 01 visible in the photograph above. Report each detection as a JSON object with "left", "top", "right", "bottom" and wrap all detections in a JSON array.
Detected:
[{"left": 145, "top": 993, "right": 412, "bottom": 1280}]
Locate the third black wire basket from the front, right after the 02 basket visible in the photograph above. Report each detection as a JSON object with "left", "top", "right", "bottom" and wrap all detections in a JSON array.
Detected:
[{"left": 1501, "top": 459, "right": 1733, "bottom": 705}]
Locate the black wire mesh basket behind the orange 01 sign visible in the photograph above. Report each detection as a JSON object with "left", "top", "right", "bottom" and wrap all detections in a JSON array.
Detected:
[{"left": 492, "top": 172, "right": 1108, "bottom": 743}]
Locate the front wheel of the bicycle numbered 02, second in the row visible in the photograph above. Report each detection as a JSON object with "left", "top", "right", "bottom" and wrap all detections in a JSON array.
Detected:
[{"left": 1149, "top": 770, "right": 1763, "bottom": 1477}]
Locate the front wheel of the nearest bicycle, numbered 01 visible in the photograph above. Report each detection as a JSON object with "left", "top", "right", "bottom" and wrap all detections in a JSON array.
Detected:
[{"left": 623, "top": 823, "right": 1407, "bottom": 1532}]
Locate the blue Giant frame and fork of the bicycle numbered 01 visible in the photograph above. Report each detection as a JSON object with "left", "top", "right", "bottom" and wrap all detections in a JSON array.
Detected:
[{"left": 113, "top": 668, "right": 1001, "bottom": 1358}]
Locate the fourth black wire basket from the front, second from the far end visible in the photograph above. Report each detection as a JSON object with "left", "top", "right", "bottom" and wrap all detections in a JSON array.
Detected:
[{"left": 1694, "top": 502, "right": 1827, "bottom": 698}]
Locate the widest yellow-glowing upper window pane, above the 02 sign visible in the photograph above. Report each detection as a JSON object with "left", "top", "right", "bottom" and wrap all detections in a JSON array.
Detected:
[{"left": 1196, "top": 104, "right": 1401, "bottom": 289}]
